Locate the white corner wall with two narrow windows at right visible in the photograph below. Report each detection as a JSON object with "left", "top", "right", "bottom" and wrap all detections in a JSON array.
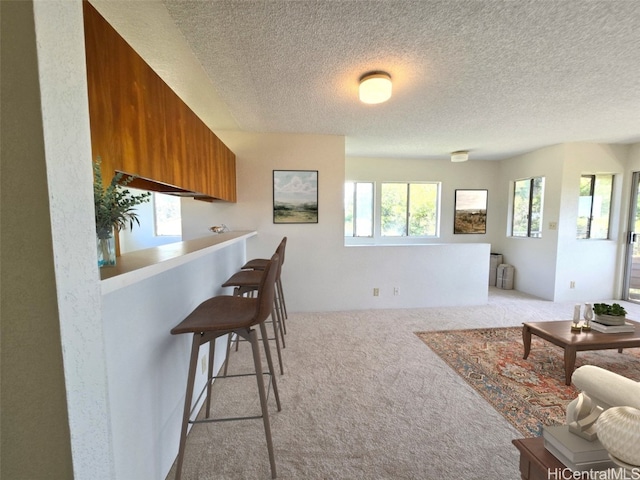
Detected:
[{"left": 498, "top": 143, "right": 630, "bottom": 302}]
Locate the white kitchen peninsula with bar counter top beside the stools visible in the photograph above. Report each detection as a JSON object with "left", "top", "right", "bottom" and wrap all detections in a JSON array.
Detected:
[{"left": 101, "top": 232, "right": 256, "bottom": 479}]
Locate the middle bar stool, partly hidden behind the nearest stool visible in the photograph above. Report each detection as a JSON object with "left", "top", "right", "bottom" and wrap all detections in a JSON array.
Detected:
[{"left": 222, "top": 246, "right": 285, "bottom": 375}]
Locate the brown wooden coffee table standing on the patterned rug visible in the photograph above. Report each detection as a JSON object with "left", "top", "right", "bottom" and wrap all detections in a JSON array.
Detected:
[{"left": 522, "top": 319, "right": 640, "bottom": 385}]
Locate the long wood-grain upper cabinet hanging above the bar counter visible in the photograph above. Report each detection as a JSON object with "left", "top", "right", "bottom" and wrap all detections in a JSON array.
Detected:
[{"left": 83, "top": 1, "right": 236, "bottom": 202}]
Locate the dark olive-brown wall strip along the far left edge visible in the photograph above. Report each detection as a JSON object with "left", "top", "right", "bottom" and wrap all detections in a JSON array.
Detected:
[{"left": 0, "top": 2, "right": 73, "bottom": 480}]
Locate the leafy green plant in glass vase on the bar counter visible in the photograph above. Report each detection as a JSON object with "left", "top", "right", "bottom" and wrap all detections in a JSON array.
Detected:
[{"left": 93, "top": 157, "right": 151, "bottom": 267}]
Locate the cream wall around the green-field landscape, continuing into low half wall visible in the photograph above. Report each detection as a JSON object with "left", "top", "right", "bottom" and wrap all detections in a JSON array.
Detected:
[{"left": 182, "top": 132, "right": 490, "bottom": 311}]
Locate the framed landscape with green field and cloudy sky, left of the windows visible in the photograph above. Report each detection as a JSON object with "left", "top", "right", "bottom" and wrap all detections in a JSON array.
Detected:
[{"left": 273, "top": 170, "right": 318, "bottom": 223}]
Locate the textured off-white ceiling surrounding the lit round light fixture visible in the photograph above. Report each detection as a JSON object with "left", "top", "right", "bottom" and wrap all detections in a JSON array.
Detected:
[{"left": 163, "top": 0, "right": 640, "bottom": 160}]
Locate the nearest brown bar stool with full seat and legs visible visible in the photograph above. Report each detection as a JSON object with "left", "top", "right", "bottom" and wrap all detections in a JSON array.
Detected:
[{"left": 171, "top": 254, "right": 282, "bottom": 480}]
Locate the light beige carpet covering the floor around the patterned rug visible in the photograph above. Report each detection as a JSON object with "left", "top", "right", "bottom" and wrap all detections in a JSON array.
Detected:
[{"left": 167, "top": 288, "right": 640, "bottom": 480}]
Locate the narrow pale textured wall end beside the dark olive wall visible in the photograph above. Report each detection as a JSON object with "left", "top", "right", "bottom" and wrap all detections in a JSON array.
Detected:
[{"left": 30, "top": 0, "right": 114, "bottom": 479}]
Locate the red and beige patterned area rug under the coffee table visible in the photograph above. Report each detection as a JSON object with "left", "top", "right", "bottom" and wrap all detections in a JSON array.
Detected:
[{"left": 416, "top": 327, "right": 640, "bottom": 437}]
